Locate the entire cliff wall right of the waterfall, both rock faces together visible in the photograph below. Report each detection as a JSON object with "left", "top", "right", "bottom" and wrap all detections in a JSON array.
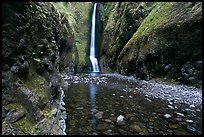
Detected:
[{"left": 100, "top": 2, "right": 202, "bottom": 87}]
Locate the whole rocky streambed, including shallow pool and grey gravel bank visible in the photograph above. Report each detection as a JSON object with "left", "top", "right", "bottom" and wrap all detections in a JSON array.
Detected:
[{"left": 63, "top": 74, "right": 202, "bottom": 135}]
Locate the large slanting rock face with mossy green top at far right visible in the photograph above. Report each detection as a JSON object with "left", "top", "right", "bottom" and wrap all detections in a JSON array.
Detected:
[{"left": 117, "top": 2, "right": 202, "bottom": 85}]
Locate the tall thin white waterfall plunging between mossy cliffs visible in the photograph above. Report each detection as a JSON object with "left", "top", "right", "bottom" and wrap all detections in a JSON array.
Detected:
[{"left": 89, "top": 3, "right": 99, "bottom": 72}]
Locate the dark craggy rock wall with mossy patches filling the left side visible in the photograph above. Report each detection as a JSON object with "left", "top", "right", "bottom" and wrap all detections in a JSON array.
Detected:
[{"left": 2, "top": 2, "right": 78, "bottom": 134}]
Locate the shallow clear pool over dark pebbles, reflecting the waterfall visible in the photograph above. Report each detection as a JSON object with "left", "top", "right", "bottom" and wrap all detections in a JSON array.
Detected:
[{"left": 65, "top": 76, "right": 202, "bottom": 135}]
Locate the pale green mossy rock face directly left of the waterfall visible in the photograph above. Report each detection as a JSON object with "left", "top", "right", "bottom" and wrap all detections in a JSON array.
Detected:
[{"left": 52, "top": 2, "right": 93, "bottom": 72}]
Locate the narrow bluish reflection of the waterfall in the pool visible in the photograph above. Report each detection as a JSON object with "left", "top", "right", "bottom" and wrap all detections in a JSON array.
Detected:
[{"left": 89, "top": 84, "right": 98, "bottom": 131}]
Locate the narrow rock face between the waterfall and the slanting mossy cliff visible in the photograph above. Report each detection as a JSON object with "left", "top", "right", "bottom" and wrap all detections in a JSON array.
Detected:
[{"left": 100, "top": 2, "right": 152, "bottom": 72}]
